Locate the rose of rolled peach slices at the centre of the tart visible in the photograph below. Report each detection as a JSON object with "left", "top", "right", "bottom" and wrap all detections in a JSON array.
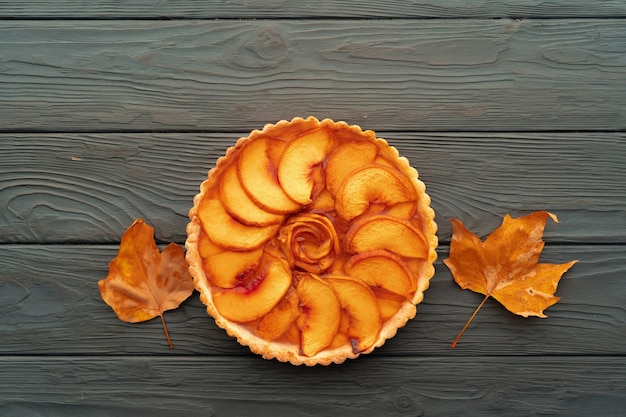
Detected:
[{"left": 278, "top": 213, "right": 340, "bottom": 274}]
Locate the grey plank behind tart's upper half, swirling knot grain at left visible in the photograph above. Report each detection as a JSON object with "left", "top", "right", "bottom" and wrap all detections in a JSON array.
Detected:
[{"left": 0, "top": 132, "right": 626, "bottom": 243}]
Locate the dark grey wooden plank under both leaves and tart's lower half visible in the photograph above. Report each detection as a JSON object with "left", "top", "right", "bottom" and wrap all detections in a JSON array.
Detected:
[{"left": 0, "top": 245, "right": 626, "bottom": 357}]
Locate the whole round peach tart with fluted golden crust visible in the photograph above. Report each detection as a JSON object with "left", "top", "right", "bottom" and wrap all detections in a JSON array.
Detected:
[{"left": 186, "top": 117, "right": 437, "bottom": 365}]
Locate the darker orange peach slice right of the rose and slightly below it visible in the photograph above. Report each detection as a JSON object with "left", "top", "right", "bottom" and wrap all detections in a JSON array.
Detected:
[{"left": 344, "top": 250, "right": 414, "bottom": 299}]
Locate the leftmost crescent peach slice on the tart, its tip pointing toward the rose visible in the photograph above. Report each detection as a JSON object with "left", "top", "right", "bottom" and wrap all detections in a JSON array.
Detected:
[{"left": 198, "top": 197, "right": 280, "bottom": 250}]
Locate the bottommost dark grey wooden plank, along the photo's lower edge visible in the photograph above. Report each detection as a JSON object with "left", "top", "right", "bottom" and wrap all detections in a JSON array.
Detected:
[{"left": 0, "top": 355, "right": 626, "bottom": 417}]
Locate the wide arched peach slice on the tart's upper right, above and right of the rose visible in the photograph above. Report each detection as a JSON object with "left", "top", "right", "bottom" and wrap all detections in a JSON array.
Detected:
[{"left": 335, "top": 165, "right": 417, "bottom": 220}]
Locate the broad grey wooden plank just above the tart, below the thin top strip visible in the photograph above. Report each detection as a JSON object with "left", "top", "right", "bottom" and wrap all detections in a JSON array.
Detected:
[{"left": 0, "top": 19, "right": 626, "bottom": 131}]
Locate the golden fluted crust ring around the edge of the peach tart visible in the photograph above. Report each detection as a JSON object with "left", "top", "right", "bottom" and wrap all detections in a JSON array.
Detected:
[{"left": 185, "top": 117, "right": 438, "bottom": 366}]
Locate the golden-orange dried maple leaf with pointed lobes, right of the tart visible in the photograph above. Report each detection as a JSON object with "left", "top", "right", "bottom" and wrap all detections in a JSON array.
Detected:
[{"left": 443, "top": 211, "right": 577, "bottom": 347}]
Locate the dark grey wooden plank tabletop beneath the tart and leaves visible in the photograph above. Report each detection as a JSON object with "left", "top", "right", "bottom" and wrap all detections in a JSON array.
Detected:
[{"left": 0, "top": 0, "right": 626, "bottom": 417}]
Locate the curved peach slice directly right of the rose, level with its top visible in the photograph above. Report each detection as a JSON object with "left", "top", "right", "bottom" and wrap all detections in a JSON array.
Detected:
[{"left": 344, "top": 214, "right": 428, "bottom": 258}]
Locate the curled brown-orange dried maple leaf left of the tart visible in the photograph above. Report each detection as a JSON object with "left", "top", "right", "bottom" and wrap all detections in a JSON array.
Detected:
[{"left": 98, "top": 219, "right": 194, "bottom": 348}]
